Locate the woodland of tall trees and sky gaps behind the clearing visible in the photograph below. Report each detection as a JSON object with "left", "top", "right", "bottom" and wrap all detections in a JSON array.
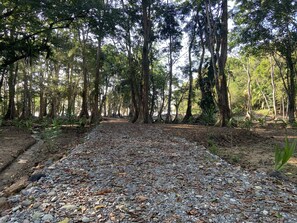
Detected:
[{"left": 0, "top": 0, "right": 297, "bottom": 126}]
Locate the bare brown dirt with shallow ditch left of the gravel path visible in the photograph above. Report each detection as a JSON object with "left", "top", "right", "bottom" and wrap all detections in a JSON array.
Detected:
[{"left": 0, "top": 126, "right": 88, "bottom": 192}]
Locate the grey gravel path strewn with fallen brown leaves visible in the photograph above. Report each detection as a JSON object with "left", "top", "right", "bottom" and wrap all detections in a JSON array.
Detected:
[{"left": 0, "top": 122, "right": 297, "bottom": 223}]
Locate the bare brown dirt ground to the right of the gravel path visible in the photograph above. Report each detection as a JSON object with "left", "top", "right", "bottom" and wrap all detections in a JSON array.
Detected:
[{"left": 160, "top": 125, "right": 297, "bottom": 183}]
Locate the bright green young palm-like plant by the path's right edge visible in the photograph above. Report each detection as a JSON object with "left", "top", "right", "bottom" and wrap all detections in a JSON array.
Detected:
[{"left": 274, "top": 137, "right": 297, "bottom": 171}]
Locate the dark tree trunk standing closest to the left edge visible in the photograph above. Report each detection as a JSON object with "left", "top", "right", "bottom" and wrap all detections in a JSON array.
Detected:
[{"left": 4, "top": 63, "right": 18, "bottom": 120}]
